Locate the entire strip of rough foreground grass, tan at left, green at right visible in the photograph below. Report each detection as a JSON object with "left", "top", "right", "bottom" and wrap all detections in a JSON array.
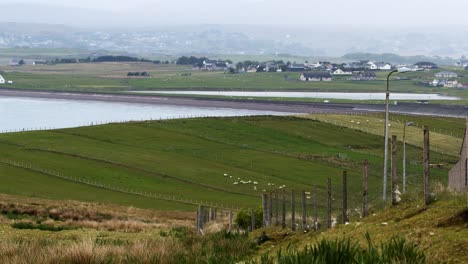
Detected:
[{"left": 0, "top": 191, "right": 468, "bottom": 264}]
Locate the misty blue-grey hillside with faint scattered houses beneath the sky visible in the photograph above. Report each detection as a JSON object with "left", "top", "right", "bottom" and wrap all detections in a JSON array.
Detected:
[{"left": 0, "top": 3, "right": 468, "bottom": 58}]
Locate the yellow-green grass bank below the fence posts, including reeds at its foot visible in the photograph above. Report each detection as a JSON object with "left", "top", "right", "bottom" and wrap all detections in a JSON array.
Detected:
[{"left": 252, "top": 189, "right": 468, "bottom": 263}]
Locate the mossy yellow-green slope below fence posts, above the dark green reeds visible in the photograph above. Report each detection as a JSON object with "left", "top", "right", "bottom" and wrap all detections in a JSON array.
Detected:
[{"left": 251, "top": 193, "right": 468, "bottom": 263}]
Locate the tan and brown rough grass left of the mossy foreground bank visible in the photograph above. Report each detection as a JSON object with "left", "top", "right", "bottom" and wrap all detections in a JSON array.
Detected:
[{"left": 0, "top": 195, "right": 256, "bottom": 263}]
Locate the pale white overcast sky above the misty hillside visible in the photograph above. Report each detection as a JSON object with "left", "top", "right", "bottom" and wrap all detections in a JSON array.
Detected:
[{"left": 0, "top": 0, "right": 468, "bottom": 26}]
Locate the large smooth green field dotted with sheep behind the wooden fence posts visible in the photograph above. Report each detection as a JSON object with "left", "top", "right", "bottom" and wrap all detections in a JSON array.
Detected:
[{"left": 0, "top": 117, "right": 463, "bottom": 210}]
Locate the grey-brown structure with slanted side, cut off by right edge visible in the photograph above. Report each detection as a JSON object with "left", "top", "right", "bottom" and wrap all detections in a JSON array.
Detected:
[{"left": 448, "top": 120, "right": 468, "bottom": 192}]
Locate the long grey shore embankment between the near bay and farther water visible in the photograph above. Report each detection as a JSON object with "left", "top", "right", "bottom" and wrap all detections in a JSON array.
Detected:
[{"left": 0, "top": 89, "right": 468, "bottom": 118}]
